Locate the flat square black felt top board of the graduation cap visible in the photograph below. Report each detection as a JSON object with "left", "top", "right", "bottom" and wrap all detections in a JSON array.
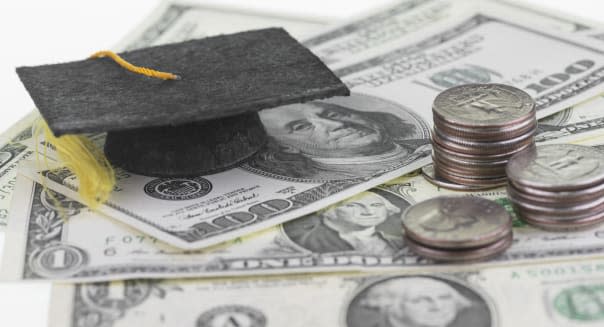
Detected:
[{"left": 17, "top": 28, "right": 349, "bottom": 136}]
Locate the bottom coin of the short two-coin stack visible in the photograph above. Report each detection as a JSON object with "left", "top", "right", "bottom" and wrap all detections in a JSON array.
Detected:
[{"left": 405, "top": 233, "right": 513, "bottom": 262}]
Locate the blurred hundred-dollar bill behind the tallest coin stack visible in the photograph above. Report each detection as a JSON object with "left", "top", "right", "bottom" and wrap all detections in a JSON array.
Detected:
[{"left": 332, "top": 6, "right": 604, "bottom": 122}]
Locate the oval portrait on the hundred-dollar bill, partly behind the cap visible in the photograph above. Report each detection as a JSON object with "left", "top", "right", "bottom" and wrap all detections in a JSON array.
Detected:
[{"left": 244, "top": 94, "right": 430, "bottom": 181}]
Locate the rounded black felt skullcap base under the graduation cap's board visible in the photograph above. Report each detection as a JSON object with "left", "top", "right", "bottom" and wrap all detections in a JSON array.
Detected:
[{"left": 105, "top": 112, "right": 268, "bottom": 177}]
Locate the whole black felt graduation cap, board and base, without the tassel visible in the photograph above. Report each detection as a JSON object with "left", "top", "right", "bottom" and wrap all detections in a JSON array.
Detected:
[{"left": 17, "top": 28, "right": 349, "bottom": 177}]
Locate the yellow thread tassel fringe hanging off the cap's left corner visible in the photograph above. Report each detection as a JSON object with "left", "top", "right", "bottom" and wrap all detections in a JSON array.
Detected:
[{"left": 37, "top": 119, "right": 116, "bottom": 210}]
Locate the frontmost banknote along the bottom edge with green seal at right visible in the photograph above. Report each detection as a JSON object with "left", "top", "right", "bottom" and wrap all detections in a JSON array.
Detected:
[{"left": 49, "top": 259, "right": 604, "bottom": 327}]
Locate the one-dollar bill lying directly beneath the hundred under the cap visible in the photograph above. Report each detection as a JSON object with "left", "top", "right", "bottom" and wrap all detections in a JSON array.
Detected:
[{"left": 8, "top": 124, "right": 604, "bottom": 281}]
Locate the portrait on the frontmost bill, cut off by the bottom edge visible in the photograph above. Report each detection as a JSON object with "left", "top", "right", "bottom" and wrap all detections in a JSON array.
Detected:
[{"left": 346, "top": 276, "right": 492, "bottom": 327}]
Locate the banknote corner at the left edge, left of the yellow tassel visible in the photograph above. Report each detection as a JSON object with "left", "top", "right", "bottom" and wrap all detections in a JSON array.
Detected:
[{"left": 0, "top": 112, "right": 39, "bottom": 229}]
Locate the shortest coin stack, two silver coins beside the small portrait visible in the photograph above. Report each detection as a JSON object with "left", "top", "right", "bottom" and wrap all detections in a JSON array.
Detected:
[{"left": 403, "top": 196, "right": 512, "bottom": 262}]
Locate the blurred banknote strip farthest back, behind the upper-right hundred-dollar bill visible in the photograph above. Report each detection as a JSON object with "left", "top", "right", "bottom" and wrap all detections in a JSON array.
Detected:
[{"left": 304, "top": 0, "right": 599, "bottom": 65}]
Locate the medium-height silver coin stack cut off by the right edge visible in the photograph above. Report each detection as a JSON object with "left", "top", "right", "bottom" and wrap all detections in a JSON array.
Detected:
[{"left": 507, "top": 144, "right": 604, "bottom": 230}]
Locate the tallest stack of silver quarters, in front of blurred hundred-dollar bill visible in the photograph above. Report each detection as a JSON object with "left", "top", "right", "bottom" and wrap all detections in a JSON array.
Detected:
[{"left": 424, "top": 84, "right": 537, "bottom": 189}]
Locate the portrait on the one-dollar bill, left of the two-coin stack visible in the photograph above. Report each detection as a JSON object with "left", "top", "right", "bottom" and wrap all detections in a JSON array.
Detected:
[{"left": 283, "top": 189, "right": 409, "bottom": 257}]
